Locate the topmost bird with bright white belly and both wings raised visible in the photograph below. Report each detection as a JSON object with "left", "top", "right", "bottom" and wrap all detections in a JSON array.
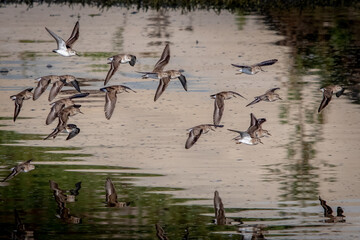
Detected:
[{"left": 45, "top": 21, "right": 80, "bottom": 57}]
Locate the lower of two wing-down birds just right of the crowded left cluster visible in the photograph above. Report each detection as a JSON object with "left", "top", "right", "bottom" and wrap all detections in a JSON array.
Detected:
[{"left": 100, "top": 85, "right": 136, "bottom": 120}]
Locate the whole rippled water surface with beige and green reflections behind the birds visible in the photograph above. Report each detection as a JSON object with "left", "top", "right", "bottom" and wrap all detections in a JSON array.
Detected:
[{"left": 0, "top": 5, "right": 360, "bottom": 239}]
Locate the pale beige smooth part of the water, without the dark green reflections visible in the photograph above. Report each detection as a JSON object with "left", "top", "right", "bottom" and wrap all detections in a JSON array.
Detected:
[{"left": 0, "top": 3, "right": 360, "bottom": 231}]
